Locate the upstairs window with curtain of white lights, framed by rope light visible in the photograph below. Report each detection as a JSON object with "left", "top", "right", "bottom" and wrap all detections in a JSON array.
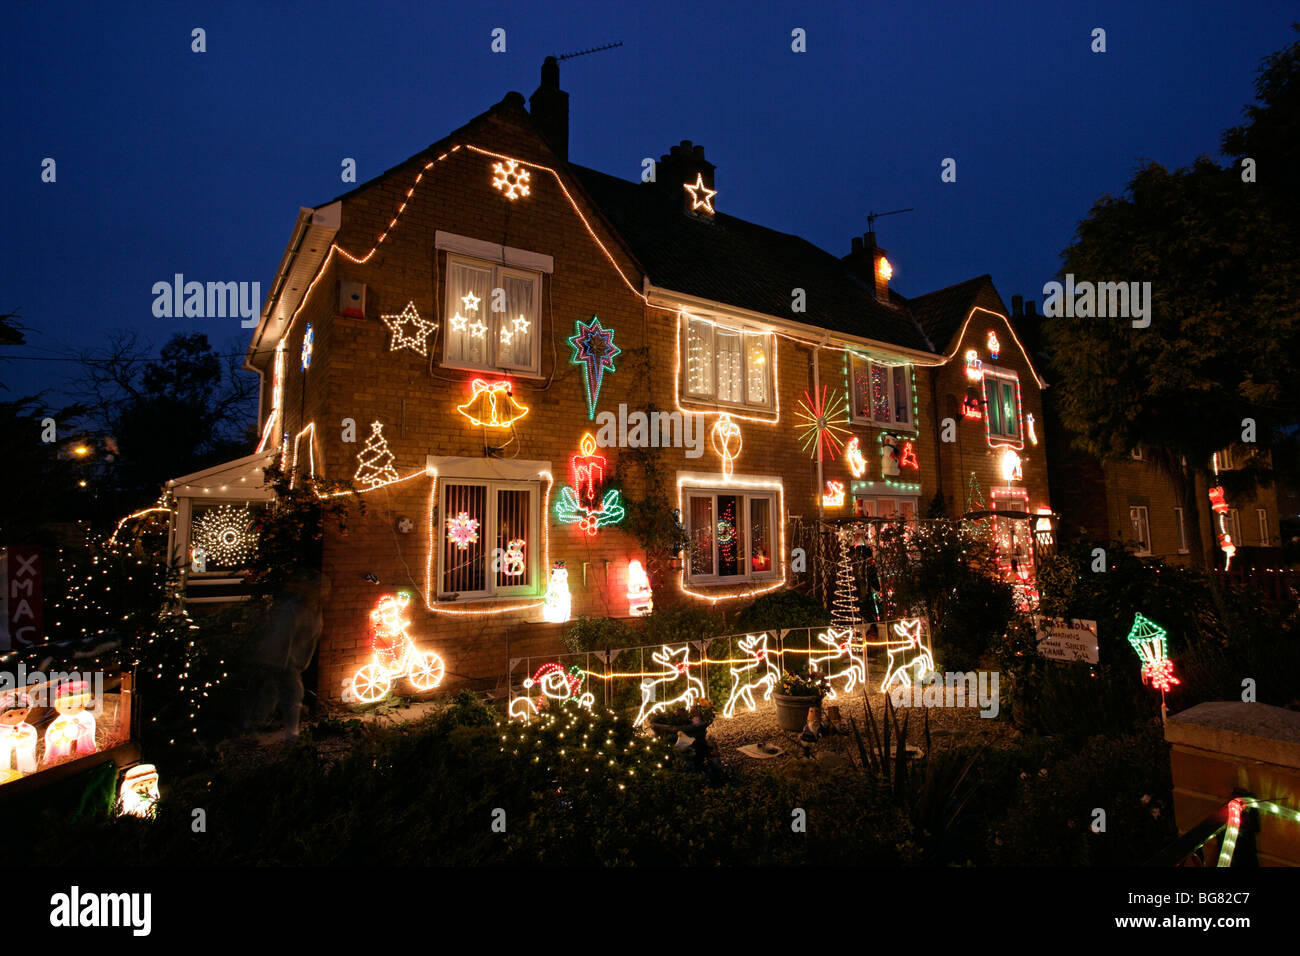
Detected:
[{"left": 683, "top": 316, "right": 772, "bottom": 407}]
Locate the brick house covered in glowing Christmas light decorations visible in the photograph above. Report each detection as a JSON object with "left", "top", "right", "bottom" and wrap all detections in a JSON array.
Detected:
[{"left": 173, "top": 59, "right": 1050, "bottom": 696}]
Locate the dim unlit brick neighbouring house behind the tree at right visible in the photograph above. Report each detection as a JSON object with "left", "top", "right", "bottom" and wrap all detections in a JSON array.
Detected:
[{"left": 1011, "top": 295, "right": 1283, "bottom": 568}]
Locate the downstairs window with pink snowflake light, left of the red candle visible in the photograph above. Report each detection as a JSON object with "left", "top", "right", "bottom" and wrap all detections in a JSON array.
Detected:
[{"left": 434, "top": 479, "right": 541, "bottom": 601}]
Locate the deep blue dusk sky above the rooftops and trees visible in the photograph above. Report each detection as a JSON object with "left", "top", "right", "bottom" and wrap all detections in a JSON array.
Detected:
[{"left": 0, "top": 0, "right": 1296, "bottom": 403}]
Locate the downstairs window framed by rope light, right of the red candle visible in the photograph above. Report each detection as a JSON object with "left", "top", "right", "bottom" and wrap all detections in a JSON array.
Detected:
[{"left": 686, "top": 488, "right": 780, "bottom": 584}]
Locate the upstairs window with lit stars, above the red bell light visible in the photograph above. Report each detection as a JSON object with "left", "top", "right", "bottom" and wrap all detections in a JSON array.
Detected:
[{"left": 442, "top": 255, "right": 542, "bottom": 375}]
